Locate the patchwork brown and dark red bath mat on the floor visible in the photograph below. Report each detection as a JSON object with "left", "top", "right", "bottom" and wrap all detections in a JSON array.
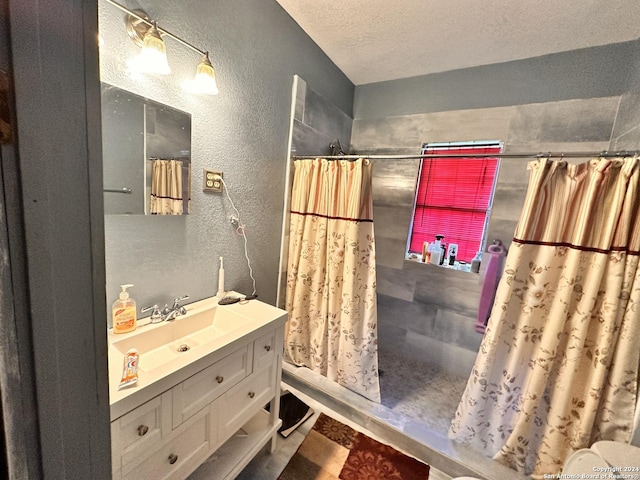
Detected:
[{"left": 278, "top": 413, "right": 429, "bottom": 480}]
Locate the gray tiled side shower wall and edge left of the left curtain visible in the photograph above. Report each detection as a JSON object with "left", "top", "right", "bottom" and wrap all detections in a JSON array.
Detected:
[{"left": 277, "top": 75, "right": 353, "bottom": 308}]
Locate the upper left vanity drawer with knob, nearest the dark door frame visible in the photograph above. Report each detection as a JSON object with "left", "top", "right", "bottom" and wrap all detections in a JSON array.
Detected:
[{"left": 111, "top": 394, "right": 171, "bottom": 469}]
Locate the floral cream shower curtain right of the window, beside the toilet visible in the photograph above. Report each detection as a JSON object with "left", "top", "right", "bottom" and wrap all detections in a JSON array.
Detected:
[{"left": 449, "top": 158, "right": 640, "bottom": 478}]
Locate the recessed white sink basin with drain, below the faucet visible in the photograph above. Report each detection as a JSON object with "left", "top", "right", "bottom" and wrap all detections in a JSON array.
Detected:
[{"left": 112, "top": 306, "right": 251, "bottom": 372}]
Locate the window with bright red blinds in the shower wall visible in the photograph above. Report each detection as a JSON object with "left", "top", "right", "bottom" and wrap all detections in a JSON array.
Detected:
[{"left": 409, "top": 142, "right": 502, "bottom": 263}]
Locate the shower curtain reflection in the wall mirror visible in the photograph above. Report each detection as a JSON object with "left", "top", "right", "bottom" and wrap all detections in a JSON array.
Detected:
[{"left": 149, "top": 159, "right": 183, "bottom": 215}]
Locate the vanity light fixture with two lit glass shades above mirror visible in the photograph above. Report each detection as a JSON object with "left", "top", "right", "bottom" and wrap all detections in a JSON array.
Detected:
[{"left": 107, "top": 0, "right": 218, "bottom": 95}]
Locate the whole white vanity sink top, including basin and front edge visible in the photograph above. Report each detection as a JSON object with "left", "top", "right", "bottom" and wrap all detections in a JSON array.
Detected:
[{"left": 108, "top": 292, "right": 286, "bottom": 418}]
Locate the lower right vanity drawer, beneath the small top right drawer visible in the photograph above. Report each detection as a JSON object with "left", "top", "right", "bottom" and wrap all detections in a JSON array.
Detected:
[{"left": 219, "top": 365, "right": 276, "bottom": 439}]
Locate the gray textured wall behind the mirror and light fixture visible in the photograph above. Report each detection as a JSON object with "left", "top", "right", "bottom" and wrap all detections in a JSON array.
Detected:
[{"left": 99, "top": 0, "right": 354, "bottom": 322}]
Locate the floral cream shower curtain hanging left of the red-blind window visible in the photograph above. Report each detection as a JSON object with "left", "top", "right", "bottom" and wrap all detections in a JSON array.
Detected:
[{"left": 285, "top": 159, "right": 380, "bottom": 402}]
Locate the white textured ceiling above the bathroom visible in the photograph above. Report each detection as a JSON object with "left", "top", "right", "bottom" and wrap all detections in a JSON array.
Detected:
[{"left": 277, "top": 0, "right": 640, "bottom": 85}]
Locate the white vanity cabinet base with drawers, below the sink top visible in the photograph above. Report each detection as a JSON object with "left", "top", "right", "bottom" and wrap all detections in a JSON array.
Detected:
[{"left": 111, "top": 298, "right": 285, "bottom": 480}]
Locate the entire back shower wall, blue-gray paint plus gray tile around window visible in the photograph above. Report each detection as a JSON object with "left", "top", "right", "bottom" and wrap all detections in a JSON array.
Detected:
[{"left": 351, "top": 42, "right": 640, "bottom": 376}]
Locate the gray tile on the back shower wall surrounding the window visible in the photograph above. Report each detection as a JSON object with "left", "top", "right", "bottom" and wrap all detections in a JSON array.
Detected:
[{"left": 351, "top": 96, "right": 620, "bottom": 376}]
